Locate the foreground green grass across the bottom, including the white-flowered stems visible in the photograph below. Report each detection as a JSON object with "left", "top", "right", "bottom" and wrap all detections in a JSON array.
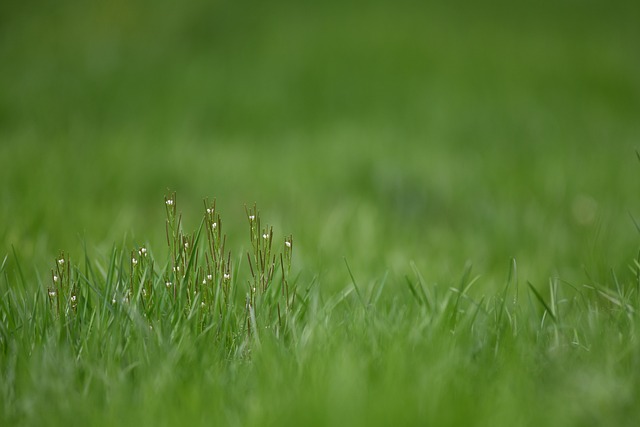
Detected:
[{"left": 0, "top": 194, "right": 640, "bottom": 425}]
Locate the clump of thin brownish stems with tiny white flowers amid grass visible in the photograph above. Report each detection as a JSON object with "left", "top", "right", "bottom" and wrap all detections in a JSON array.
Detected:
[{"left": 48, "top": 193, "right": 296, "bottom": 344}]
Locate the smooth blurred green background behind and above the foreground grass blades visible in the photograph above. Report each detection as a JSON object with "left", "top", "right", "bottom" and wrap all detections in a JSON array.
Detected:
[{"left": 0, "top": 0, "right": 640, "bottom": 287}]
